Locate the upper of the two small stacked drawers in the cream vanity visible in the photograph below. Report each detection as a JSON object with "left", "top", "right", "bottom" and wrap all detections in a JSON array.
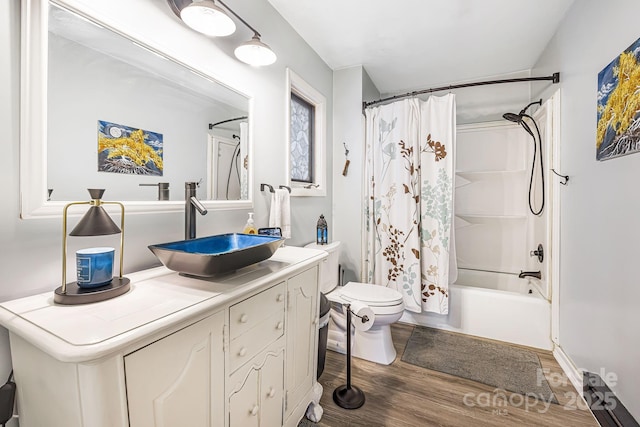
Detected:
[{"left": 229, "top": 282, "right": 286, "bottom": 340}]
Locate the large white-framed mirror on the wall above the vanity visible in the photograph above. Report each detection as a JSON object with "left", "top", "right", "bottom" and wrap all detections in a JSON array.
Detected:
[{"left": 21, "top": 0, "right": 252, "bottom": 218}]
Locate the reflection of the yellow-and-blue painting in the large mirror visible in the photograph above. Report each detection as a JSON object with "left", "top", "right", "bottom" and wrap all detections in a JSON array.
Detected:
[{"left": 98, "top": 120, "right": 163, "bottom": 176}]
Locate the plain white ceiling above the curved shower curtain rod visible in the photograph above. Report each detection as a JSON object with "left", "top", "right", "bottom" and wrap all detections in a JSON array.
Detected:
[{"left": 268, "top": 0, "right": 574, "bottom": 94}]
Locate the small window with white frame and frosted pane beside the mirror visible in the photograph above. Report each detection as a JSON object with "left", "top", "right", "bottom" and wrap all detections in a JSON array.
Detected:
[{"left": 287, "top": 69, "right": 326, "bottom": 196}]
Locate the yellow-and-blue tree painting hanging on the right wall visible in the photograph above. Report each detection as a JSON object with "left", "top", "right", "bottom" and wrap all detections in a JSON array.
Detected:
[{"left": 596, "top": 39, "right": 640, "bottom": 160}]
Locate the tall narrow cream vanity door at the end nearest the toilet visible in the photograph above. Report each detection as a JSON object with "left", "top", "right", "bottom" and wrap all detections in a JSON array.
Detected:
[{"left": 285, "top": 267, "right": 318, "bottom": 413}]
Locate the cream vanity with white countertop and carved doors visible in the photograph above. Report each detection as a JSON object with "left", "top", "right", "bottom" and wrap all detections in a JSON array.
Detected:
[{"left": 0, "top": 247, "right": 326, "bottom": 427}]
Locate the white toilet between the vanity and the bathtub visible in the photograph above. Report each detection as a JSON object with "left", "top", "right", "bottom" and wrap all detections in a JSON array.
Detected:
[{"left": 305, "top": 242, "right": 404, "bottom": 365}]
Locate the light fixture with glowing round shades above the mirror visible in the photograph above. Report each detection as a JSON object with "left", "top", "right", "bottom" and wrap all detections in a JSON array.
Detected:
[{"left": 167, "top": 0, "right": 277, "bottom": 66}]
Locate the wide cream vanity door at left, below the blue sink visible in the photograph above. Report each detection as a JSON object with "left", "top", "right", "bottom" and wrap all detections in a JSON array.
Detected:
[{"left": 124, "top": 312, "right": 225, "bottom": 427}]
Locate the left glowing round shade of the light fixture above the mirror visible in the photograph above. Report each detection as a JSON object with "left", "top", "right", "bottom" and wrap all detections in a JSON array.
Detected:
[{"left": 180, "top": 0, "right": 236, "bottom": 37}]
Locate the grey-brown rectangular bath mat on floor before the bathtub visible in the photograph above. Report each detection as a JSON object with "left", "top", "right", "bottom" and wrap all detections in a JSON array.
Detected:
[{"left": 402, "top": 326, "right": 558, "bottom": 403}]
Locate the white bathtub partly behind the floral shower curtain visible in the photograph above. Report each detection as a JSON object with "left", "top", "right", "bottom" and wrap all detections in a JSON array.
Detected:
[{"left": 400, "top": 269, "right": 553, "bottom": 350}]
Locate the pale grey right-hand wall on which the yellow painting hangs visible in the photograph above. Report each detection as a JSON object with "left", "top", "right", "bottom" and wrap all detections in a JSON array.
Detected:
[{"left": 534, "top": 0, "right": 640, "bottom": 419}]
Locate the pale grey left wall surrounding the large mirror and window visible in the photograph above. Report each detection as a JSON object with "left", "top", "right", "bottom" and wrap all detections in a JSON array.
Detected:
[{"left": 0, "top": 0, "right": 333, "bottom": 412}]
